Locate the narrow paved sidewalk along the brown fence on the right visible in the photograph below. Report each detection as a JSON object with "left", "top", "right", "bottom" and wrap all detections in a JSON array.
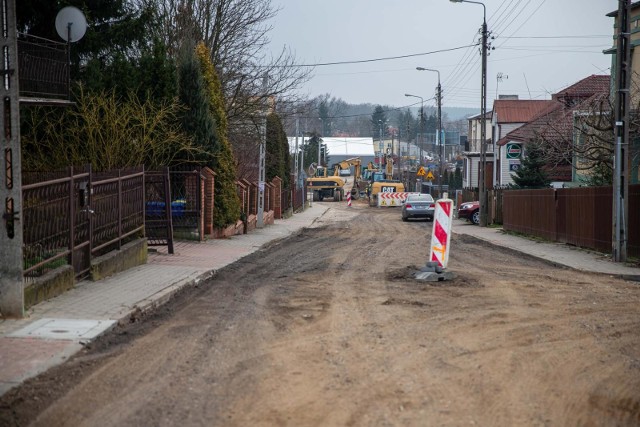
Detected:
[{"left": 453, "top": 219, "right": 640, "bottom": 281}]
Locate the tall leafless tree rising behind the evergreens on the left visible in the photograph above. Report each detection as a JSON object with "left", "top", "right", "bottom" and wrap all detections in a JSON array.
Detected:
[{"left": 132, "top": 0, "right": 312, "bottom": 179}]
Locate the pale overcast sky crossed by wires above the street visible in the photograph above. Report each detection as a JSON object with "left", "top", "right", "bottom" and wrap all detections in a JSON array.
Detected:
[{"left": 270, "top": 0, "right": 618, "bottom": 109}]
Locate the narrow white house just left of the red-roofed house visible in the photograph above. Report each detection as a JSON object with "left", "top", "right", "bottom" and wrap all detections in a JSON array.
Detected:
[{"left": 462, "top": 111, "right": 493, "bottom": 188}]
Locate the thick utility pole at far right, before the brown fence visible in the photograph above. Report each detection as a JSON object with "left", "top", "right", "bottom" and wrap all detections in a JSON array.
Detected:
[{"left": 612, "top": 0, "right": 633, "bottom": 262}]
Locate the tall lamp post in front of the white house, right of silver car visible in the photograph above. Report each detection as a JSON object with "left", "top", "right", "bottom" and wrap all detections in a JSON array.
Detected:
[{"left": 450, "top": 0, "right": 489, "bottom": 227}]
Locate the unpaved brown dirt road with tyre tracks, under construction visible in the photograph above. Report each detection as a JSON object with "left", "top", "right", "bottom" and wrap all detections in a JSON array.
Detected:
[{"left": 0, "top": 200, "right": 640, "bottom": 426}]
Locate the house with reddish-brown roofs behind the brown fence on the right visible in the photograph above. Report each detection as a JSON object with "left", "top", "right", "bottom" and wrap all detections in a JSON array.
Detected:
[{"left": 494, "top": 75, "right": 610, "bottom": 186}]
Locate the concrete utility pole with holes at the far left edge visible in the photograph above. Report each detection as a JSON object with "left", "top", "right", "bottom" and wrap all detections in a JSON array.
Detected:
[{"left": 0, "top": 0, "right": 24, "bottom": 317}]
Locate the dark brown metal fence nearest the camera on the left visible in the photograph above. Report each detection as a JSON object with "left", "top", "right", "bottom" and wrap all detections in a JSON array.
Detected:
[{"left": 22, "top": 166, "right": 144, "bottom": 279}]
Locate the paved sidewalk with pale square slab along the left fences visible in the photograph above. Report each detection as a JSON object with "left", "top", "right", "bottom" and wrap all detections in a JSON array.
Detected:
[{"left": 0, "top": 203, "right": 328, "bottom": 395}]
